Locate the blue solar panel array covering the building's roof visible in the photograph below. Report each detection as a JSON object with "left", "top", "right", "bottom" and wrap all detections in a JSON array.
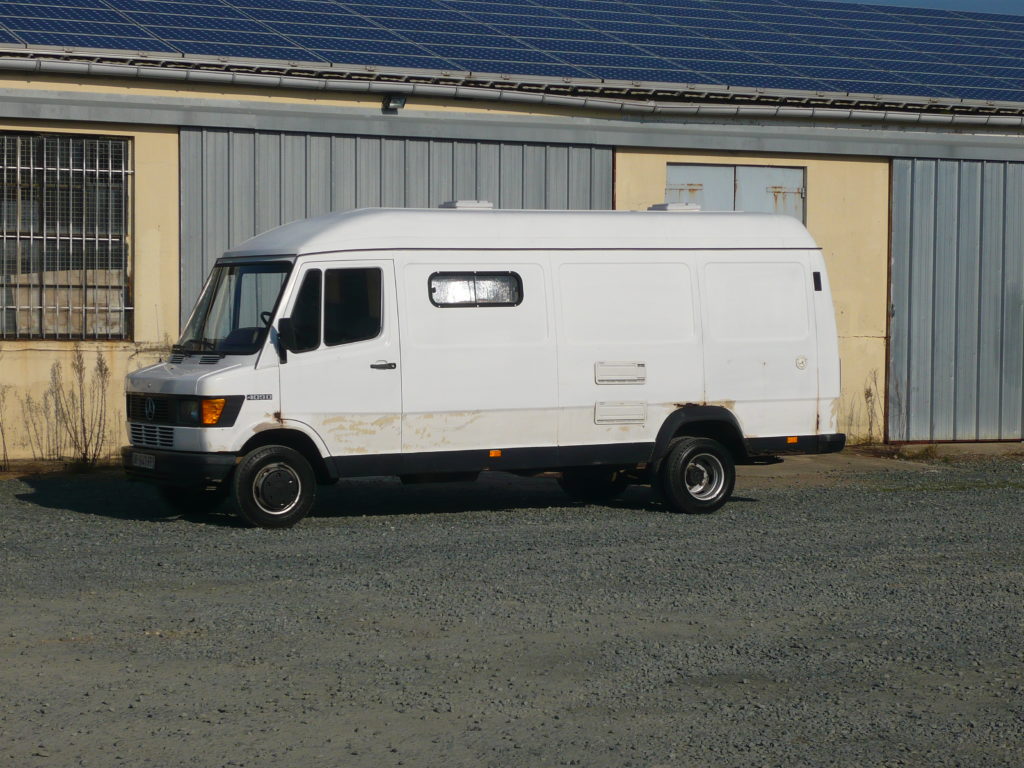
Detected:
[{"left": 0, "top": 0, "right": 1024, "bottom": 101}]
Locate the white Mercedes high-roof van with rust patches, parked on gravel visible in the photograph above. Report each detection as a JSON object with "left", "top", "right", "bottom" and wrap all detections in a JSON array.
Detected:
[{"left": 123, "top": 206, "right": 845, "bottom": 527}]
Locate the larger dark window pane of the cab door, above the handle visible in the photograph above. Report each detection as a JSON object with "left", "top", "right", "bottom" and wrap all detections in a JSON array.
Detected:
[{"left": 324, "top": 267, "right": 383, "bottom": 346}]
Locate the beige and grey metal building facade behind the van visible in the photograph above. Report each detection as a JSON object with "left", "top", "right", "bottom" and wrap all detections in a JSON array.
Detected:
[{"left": 0, "top": 55, "right": 1024, "bottom": 458}]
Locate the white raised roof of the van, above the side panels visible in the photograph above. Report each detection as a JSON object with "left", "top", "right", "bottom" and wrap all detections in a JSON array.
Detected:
[{"left": 224, "top": 208, "right": 817, "bottom": 256}]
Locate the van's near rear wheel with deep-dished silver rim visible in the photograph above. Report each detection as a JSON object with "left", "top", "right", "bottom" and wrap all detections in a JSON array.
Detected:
[{"left": 659, "top": 437, "right": 736, "bottom": 515}]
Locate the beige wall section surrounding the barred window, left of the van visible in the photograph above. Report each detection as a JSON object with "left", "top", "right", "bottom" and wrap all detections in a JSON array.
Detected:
[{"left": 0, "top": 121, "right": 178, "bottom": 459}]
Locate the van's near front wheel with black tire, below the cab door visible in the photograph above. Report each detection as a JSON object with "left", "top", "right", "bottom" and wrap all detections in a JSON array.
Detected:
[{"left": 231, "top": 445, "right": 316, "bottom": 528}]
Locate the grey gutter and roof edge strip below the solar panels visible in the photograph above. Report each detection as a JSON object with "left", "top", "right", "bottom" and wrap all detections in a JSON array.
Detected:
[{"left": 0, "top": 44, "right": 1024, "bottom": 120}]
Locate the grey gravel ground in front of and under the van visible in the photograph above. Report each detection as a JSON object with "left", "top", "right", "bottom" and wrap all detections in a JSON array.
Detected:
[{"left": 0, "top": 455, "right": 1024, "bottom": 768}]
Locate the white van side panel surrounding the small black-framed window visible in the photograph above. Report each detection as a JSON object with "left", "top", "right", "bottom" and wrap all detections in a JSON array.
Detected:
[{"left": 399, "top": 256, "right": 557, "bottom": 455}]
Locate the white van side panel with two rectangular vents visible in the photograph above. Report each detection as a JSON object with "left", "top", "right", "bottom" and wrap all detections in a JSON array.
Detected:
[{"left": 552, "top": 257, "right": 703, "bottom": 445}]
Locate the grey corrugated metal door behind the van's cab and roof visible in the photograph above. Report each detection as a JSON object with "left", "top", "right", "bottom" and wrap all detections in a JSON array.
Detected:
[{"left": 181, "top": 128, "right": 612, "bottom": 323}]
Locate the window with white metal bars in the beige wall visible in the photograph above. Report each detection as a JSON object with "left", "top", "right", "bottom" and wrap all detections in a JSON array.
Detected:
[{"left": 0, "top": 132, "right": 132, "bottom": 339}]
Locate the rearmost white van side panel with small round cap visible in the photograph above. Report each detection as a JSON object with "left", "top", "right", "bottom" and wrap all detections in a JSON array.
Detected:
[{"left": 701, "top": 251, "right": 819, "bottom": 437}]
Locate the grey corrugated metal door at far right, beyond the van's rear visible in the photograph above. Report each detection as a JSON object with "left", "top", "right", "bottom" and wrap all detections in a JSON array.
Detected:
[{"left": 889, "top": 160, "right": 1024, "bottom": 440}]
